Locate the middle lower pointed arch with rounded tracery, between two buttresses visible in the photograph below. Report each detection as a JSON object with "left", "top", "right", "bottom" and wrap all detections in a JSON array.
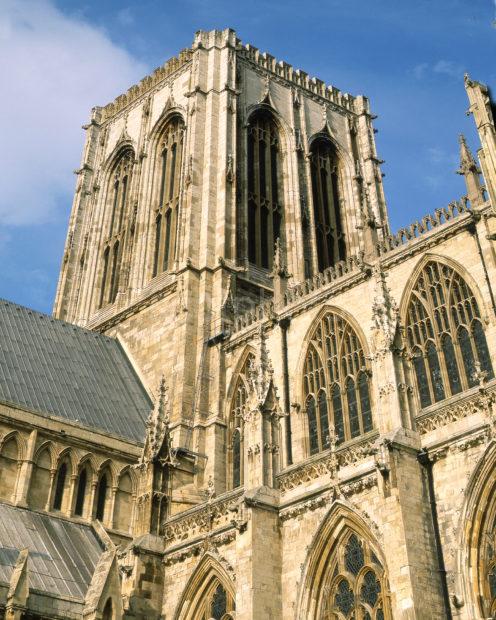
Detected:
[{"left": 296, "top": 501, "right": 392, "bottom": 620}]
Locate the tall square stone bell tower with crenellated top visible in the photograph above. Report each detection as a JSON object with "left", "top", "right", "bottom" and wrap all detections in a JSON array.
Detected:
[{"left": 54, "top": 30, "right": 388, "bottom": 484}]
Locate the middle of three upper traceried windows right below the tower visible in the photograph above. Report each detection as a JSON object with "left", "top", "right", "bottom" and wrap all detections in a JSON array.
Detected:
[{"left": 303, "top": 312, "right": 373, "bottom": 454}]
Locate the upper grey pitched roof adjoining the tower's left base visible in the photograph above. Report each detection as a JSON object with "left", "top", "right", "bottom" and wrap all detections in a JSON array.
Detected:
[{"left": 0, "top": 300, "right": 152, "bottom": 441}]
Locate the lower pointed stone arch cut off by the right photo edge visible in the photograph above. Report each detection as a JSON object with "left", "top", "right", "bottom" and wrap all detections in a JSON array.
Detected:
[{"left": 457, "top": 443, "right": 496, "bottom": 618}]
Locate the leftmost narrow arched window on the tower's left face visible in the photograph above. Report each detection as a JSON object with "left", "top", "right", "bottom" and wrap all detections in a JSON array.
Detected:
[{"left": 99, "top": 148, "right": 134, "bottom": 307}]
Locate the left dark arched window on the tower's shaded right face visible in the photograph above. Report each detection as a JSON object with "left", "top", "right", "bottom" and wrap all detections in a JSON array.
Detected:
[{"left": 247, "top": 111, "right": 283, "bottom": 269}]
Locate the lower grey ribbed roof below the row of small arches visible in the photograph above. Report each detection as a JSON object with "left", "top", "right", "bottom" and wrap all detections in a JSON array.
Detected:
[{"left": 0, "top": 504, "right": 104, "bottom": 599}]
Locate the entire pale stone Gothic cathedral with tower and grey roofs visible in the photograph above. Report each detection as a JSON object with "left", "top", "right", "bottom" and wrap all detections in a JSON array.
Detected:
[{"left": 0, "top": 30, "right": 496, "bottom": 620}]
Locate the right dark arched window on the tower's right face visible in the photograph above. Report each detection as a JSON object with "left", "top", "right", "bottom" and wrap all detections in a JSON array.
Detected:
[{"left": 310, "top": 138, "right": 346, "bottom": 271}]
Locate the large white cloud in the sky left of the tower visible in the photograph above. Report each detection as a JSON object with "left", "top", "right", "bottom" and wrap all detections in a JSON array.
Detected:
[{"left": 0, "top": 0, "right": 147, "bottom": 225}]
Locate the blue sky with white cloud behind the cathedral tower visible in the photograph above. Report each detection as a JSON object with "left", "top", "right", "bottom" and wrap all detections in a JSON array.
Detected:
[{"left": 0, "top": 0, "right": 496, "bottom": 312}]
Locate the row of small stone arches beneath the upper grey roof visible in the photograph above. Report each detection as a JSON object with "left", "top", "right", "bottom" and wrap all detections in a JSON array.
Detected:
[{"left": 0, "top": 432, "right": 136, "bottom": 533}]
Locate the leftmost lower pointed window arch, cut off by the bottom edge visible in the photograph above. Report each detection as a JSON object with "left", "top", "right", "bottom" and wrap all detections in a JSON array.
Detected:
[{"left": 174, "top": 552, "right": 236, "bottom": 620}]
